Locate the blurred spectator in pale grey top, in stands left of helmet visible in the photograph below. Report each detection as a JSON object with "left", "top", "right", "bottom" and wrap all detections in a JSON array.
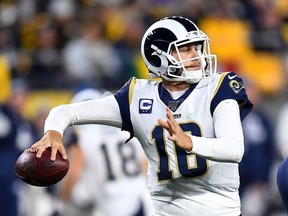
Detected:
[{"left": 63, "top": 11, "right": 121, "bottom": 88}]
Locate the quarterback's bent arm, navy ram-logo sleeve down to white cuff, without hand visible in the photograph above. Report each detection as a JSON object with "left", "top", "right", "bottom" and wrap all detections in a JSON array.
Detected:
[{"left": 190, "top": 73, "right": 252, "bottom": 162}]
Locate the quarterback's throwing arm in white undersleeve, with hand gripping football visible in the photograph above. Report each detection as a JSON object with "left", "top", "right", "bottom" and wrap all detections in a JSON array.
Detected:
[{"left": 31, "top": 95, "right": 122, "bottom": 161}]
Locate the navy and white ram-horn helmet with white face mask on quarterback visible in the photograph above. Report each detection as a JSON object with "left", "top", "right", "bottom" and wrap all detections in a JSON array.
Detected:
[{"left": 141, "top": 16, "right": 217, "bottom": 83}]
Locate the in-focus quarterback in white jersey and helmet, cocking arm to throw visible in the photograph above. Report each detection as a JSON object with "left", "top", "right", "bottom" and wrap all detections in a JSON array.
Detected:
[{"left": 31, "top": 16, "right": 252, "bottom": 216}]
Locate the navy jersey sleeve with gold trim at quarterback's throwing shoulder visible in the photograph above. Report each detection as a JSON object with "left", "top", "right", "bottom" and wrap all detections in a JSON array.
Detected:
[{"left": 114, "top": 77, "right": 136, "bottom": 138}]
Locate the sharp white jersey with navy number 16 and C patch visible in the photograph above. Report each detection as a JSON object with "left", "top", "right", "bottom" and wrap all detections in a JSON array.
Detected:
[{"left": 115, "top": 73, "right": 251, "bottom": 216}]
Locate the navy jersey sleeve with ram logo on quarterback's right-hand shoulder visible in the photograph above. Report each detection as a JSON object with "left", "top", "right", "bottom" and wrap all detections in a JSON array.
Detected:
[{"left": 210, "top": 72, "right": 253, "bottom": 120}]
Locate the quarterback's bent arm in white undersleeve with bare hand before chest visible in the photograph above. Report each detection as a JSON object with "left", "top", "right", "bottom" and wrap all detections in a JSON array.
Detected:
[{"left": 158, "top": 100, "right": 244, "bottom": 162}]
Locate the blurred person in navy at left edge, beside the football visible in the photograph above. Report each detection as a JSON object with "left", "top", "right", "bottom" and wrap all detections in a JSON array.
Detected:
[{"left": 0, "top": 79, "right": 36, "bottom": 216}]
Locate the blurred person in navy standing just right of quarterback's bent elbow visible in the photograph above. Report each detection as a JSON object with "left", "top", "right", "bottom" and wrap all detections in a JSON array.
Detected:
[{"left": 239, "top": 78, "right": 276, "bottom": 216}]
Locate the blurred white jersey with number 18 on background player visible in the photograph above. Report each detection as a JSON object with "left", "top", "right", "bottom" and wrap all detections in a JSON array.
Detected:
[{"left": 72, "top": 125, "right": 151, "bottom": 216}]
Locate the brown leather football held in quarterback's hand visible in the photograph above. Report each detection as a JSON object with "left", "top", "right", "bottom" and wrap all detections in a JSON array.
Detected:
[{"left": 14, "top": 148, "right": 69, "bottom": 187}]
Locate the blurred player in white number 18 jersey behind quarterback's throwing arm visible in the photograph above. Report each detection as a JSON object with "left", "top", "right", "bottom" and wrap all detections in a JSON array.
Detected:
[{"left": 59, "top": 89, "right": 151, "bottom": 216}]
